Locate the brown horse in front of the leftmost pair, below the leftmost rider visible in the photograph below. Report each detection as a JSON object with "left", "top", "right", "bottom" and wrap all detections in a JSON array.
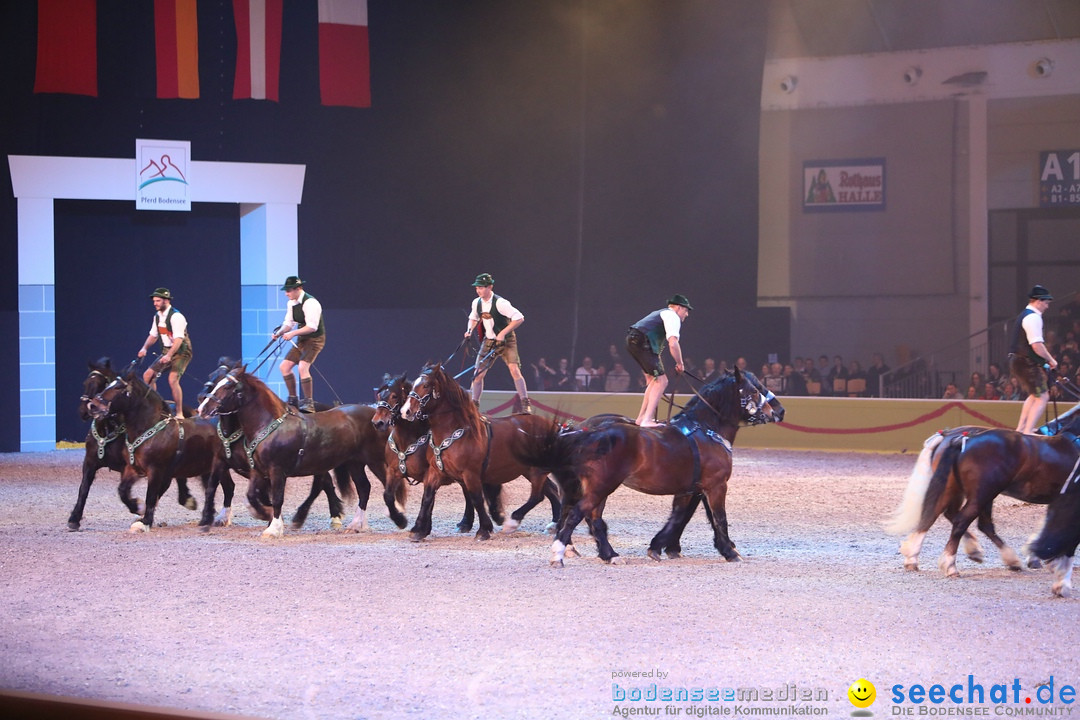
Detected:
[{"left": 89, "top": 368, "right": 229, "bottom": 532}]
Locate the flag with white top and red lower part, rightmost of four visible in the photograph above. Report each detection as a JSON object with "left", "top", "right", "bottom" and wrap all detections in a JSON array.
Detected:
[{"left": 319, "top": 0, "right": 372, "bottom": 108}]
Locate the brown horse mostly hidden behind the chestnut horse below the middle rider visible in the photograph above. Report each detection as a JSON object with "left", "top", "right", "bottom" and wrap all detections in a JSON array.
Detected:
[{"left": 372, "top": 372, "right": 503, "bottom": 532}]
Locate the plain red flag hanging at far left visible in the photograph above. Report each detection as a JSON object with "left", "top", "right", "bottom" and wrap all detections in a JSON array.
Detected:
[{"left": 33, "top": 0, "right": 97, "bottom": 97}]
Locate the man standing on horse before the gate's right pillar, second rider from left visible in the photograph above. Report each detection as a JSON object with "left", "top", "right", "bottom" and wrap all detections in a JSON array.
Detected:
[{"left": 273, "top": 275, "right": 326, "bottom": 412}]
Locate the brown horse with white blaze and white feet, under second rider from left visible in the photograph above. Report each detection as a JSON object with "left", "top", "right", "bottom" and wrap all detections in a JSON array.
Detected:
[{"left": 199, "top": 366, "right": 405, "bottom": 538}]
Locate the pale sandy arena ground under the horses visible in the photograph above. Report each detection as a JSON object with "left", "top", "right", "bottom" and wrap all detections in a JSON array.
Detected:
[{"left": 0, "top": 447, "right": 1080, "bottom": 719}]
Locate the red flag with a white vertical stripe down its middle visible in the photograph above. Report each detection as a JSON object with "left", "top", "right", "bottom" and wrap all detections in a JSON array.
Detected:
[{"left": 232, "top": 0, "right": 282, "bottom": 101}]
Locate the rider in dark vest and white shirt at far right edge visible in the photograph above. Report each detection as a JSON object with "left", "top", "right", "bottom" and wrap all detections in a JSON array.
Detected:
[{"left": 1009, "top": 285, "right": 1057, "bottom": 435}]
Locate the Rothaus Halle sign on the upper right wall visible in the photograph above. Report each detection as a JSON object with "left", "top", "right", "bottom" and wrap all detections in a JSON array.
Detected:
[{"left": 802, "top": 158, "right": 885, "bottom": 213}]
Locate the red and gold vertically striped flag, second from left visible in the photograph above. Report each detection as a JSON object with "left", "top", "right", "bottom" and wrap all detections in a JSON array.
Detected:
[{"left": 153, "top": 0, "right": 199, "bottom": 99}]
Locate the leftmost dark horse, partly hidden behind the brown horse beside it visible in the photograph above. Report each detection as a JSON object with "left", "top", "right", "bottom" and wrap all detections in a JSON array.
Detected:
[{"left": 68, "top": 357, "right": 198, "bottom": 530}]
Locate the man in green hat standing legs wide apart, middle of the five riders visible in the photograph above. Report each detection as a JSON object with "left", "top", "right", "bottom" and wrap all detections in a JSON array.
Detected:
[{"left": 465, "top": 272, "right": 532, "bottom": 413}]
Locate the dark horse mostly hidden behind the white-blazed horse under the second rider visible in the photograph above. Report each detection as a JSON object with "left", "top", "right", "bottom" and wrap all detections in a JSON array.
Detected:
[{"left": 199, "top": 356, "right": 354, "bottom": 530}]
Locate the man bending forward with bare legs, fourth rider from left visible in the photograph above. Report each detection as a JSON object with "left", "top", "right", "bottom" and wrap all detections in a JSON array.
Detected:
[{"left": 626, "top": 295, "right": 693, "bottom": 427}]
